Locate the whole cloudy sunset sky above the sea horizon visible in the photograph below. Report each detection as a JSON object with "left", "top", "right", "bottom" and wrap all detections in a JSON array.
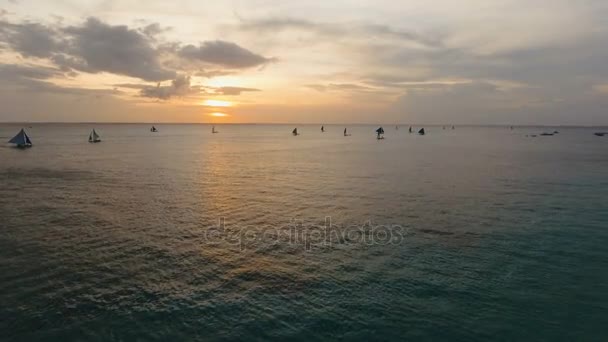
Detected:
[{"left": 0, "top": 0, "right": 608, "bottom": 125}]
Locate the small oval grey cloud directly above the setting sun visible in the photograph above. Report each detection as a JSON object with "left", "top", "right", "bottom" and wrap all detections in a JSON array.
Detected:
[{"left": 178, "top": 40, "right": 275, "bottom": 69}]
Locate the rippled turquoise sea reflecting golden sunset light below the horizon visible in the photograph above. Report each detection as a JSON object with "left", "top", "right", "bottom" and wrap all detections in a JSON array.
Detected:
[{"left": 0, "top": 124, "right": 608, "bottom": 341}]
